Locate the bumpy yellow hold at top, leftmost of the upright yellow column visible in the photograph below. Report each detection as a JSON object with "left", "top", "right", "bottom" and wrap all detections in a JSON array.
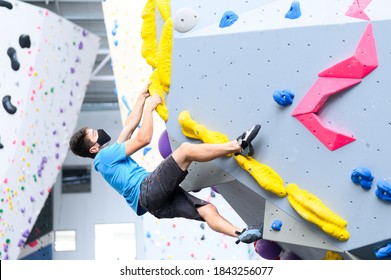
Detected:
[{"left": 141, "top": 0, "right": 157, "bottom": 68}]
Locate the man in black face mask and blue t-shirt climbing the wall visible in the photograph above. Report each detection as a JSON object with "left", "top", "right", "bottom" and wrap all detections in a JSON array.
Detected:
[{"left": 69, "top": 84, "right": 262, "bottom": 243}]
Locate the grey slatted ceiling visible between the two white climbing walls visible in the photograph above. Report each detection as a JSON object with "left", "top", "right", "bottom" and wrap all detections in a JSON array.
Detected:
[{"left": 23, "top": 0, "right": 121, "bottom": 106}]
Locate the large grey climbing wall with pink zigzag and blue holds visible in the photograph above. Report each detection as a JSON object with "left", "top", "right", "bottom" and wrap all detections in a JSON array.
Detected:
[{"left": 157, "top": 0, "right": 391, "bottom": 259}]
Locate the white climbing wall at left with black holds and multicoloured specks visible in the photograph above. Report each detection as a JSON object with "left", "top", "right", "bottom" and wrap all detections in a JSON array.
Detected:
[{"left": 0, "top": 1, "right": 99, "bottom": 259}]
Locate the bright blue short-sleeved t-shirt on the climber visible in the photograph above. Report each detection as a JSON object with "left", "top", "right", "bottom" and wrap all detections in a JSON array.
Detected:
[{"left": 94, "top": 143, "right": 149, "bottom": 216}]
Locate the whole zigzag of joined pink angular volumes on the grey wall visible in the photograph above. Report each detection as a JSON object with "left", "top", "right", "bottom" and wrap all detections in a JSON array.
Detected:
[{"left": 292, "top": 22, "right": 378, "bottom": 151}]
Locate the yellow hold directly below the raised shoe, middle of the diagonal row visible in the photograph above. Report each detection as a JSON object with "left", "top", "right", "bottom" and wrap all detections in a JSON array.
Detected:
[{"left": 235, "top": 155, "right": 286, "bottom": 197}]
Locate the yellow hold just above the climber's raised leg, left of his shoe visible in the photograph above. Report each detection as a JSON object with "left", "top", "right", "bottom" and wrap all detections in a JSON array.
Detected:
[{"left": 178, "top": 111, "right": 229, "bottom": 144}]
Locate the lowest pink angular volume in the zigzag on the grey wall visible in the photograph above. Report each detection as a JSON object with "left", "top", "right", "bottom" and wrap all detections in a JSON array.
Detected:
[{"left": 297, "top": 113, "right": 356, "bottom": 151}]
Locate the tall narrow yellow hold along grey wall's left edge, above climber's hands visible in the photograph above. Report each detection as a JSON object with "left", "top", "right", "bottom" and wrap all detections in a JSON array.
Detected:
[{"left": 157, "top": 18, "right": 172, "bottom": 92}]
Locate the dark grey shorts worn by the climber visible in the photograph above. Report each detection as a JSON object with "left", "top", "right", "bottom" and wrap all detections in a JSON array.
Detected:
[{"left": 139, "top": 155, "right": 209, "bottom": 221}]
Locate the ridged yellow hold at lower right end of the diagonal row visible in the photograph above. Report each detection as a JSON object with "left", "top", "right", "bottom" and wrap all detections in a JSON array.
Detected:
[{"left": 286, "top": 183, "right": 350, "bottom": 241}]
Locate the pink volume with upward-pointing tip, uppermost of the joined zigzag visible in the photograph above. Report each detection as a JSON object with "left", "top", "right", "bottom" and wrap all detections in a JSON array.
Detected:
[{"left": 318, "top": 24, "right": 379, "bottom": 79}]
